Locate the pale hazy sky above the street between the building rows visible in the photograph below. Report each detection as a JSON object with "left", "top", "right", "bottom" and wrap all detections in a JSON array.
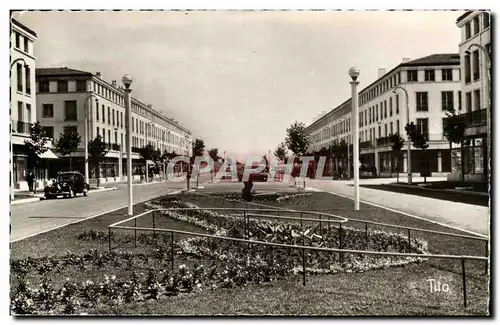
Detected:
[{"left": 14, "top": 11, "right": 462, "bottom": 157}]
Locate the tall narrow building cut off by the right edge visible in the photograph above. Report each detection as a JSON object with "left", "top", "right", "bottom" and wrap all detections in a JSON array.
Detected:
[{"left": 448, "top": 11, "right": 491, "bottom": 182}]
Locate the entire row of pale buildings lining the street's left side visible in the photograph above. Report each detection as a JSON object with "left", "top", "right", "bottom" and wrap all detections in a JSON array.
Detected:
[{"left": 11, "top": 19, "right": 193, "bottom": 190}]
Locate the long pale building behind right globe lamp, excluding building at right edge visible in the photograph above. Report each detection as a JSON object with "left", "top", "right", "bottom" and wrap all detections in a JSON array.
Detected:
[{"left": 307, "top": 54, "right": 461, "bottom": 175}]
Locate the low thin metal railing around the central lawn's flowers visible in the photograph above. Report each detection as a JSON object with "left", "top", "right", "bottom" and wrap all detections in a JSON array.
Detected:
[{"left": 108, "top": 208, "right": 488, "bottom": 307}]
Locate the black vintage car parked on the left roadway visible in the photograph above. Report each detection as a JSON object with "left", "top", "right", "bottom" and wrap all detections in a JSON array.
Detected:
[{"left": 44, "top": 172, "right": 90, "bottom": 199}]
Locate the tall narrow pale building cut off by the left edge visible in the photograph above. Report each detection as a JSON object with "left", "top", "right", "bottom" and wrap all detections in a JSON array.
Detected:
[{"left": 10, "top": 18, "right": 57, "bottom": 191}]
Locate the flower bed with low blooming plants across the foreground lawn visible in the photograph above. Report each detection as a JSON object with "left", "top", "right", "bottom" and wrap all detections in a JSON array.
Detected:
[{"left": 11, "top": 195, "right": 427, "bottom": 314}]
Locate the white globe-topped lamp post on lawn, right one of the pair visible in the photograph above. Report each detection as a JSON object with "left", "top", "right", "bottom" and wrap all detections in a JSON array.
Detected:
[{"left": 349, "top": 67, "right": 359, "bottom": 211}]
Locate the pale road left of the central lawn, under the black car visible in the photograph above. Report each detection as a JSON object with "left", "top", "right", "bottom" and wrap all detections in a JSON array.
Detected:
[{"left": 10, "top": 175, "right": 210, "bottom": 241}]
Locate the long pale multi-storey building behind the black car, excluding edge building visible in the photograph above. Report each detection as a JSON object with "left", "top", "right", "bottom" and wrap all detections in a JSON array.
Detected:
[{"left": 36, "top": 67, "right": 192, "bottom": 181}]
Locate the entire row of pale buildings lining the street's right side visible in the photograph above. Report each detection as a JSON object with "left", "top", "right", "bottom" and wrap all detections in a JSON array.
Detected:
[{"left": 307, "top": 12, "right": 491, "bottom": 181}]
